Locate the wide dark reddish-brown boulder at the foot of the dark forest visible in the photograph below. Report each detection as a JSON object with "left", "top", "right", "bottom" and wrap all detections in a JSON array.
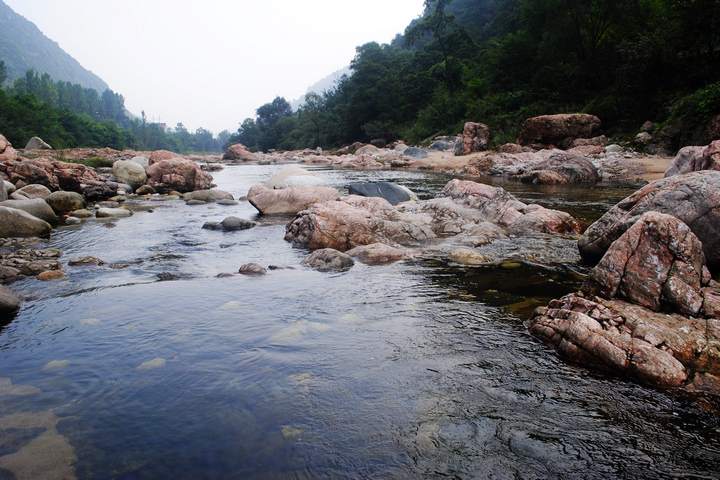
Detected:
[{"left": 517, "top": 113, "right": 602, "bottom": 148}]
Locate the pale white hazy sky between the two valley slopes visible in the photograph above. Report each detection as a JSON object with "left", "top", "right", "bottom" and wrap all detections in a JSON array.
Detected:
[{"left": 4, "top": 0, "right": 423, "bottom": 134}]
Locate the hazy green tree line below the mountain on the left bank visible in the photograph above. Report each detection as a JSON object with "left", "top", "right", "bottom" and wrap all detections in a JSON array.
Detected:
[{"left": 0, "top": 61, "right": 230, "bottom": 153}]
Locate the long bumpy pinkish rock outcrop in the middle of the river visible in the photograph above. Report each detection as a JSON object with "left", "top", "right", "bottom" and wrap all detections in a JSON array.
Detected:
[{"left": 285, "top": 180, "right": 582, "bottom": 250}]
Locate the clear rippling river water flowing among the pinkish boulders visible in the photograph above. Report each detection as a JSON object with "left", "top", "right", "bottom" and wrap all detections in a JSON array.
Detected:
[{"left": 0, "top": 166, "right": 720, "bottom": 479}]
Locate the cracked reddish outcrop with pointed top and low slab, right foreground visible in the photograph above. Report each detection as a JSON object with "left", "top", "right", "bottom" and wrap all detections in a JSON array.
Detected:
[{"left": 528, "top": 211, "right": 720, "bottom": 395}]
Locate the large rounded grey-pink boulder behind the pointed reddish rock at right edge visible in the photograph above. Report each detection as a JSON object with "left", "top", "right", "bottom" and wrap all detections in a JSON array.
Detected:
[{"left": 578, "top": 170, "right": 720, "bottom": 271}]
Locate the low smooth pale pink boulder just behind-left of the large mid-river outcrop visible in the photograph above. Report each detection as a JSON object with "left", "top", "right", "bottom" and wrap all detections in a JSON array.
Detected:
[{"left": 248, "top": 185, "right": 340, "bottom": 215}]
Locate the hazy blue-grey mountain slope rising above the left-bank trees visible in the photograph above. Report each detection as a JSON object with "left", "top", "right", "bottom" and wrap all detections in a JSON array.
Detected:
[{"left": 0, "top": 0, "right": 108, "bottom": 93}]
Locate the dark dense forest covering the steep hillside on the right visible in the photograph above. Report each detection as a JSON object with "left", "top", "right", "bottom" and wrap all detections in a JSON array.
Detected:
[{"left": 231, "top": 0, "right": 720, "bottom": 150}]
